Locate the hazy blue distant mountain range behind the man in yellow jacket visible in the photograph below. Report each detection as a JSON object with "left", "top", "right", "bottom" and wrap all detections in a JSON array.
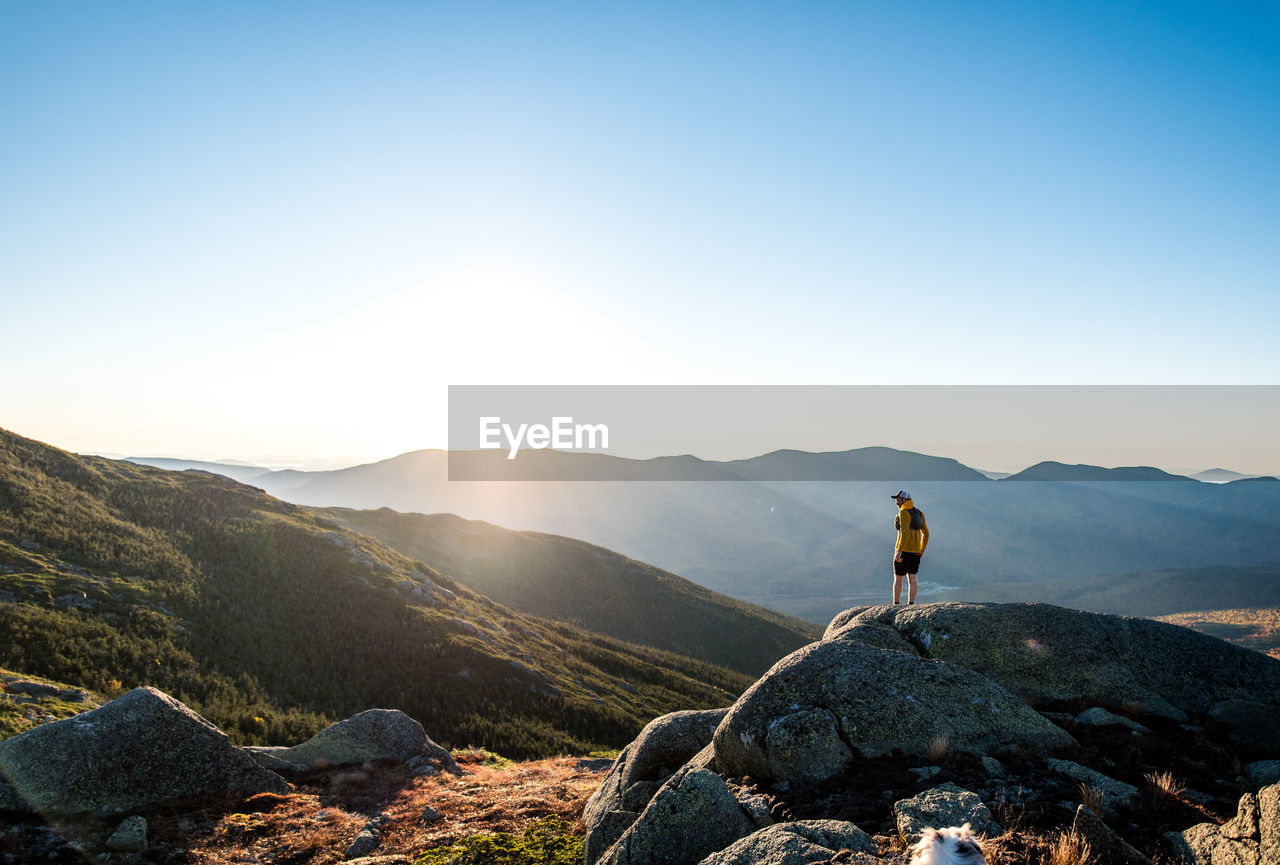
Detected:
[{"left": 129, "top": 448, "right": 1280, "bottom": 623}]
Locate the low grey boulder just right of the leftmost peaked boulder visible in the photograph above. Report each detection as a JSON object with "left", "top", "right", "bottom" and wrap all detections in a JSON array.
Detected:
[{"left": 259, "top": 709, "right": 462, "bottom": 774}]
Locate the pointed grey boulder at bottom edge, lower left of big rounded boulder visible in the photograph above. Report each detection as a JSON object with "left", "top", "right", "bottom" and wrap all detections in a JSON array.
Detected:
[{"left": 600, "top": 768, "right": 756, "bottom": 865}]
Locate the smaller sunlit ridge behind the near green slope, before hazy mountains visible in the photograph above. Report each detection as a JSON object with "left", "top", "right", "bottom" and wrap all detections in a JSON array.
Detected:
[{"left": 324, "top": 508, "right": 822, "bottom": 676}]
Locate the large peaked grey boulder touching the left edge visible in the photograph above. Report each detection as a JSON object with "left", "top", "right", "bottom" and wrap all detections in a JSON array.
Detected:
[{"left": 0, "top": 687, "right": 289, "bottom": 814}]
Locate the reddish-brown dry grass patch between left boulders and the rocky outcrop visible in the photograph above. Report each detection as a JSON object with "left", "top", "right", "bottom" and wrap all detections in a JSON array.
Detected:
[{"left": 156, "top": 758, "right": 603, "bottom": 865}]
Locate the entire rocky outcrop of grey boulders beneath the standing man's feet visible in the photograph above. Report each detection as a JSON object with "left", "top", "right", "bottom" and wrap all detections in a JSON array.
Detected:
[{"left": 584, "top": 603, "right": 1280, "bottom": 865}]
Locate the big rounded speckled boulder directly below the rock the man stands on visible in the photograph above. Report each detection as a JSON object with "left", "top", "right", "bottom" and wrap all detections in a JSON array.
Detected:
[{"left": 714, "top": 639, "right": 1075, "bottom": 782}]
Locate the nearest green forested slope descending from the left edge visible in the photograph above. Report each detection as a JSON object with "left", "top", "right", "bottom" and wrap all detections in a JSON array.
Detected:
[{"left": 0, "top": 430, "right": 750, "bottom": 756}]
